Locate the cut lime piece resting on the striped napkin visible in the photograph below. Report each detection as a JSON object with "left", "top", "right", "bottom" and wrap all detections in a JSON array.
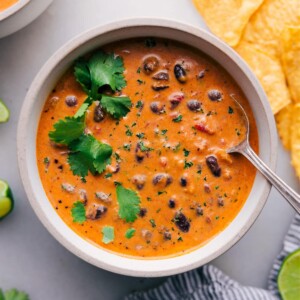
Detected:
[{"left": 277, "top": 249, "right": 300, "bottom": 300}]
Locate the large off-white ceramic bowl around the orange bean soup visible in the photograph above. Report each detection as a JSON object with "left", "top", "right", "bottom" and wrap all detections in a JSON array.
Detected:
[{"left": 18, "top": 18, "right": 277, "bottom": 277}]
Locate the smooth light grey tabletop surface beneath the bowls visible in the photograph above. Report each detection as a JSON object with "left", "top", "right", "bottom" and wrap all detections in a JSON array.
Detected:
[{"left": 0, "top": 0, "right": 299, "bottom": 300}]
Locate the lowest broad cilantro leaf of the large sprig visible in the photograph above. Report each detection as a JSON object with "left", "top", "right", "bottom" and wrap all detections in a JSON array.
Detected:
[{"left": 68, "top": 135, "right": 112, "bottom": 177}]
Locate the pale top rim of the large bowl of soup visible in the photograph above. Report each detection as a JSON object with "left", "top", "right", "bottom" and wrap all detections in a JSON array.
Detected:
[{"left": 17, "top": 17, "right": 277, "bottom": 277}]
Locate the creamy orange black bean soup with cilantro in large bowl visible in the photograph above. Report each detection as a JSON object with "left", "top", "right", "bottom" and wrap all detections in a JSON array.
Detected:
[{"left": 37, "top": 39, "right": 258, "bottom": 258}]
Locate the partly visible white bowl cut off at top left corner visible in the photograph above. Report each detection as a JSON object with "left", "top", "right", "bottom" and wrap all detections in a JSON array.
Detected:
[{"left": 0, "top": 0, "right": 53, "bottom": 38}]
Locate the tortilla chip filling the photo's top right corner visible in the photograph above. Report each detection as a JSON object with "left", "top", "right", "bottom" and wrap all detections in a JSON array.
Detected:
[{"left": 243, "top": 0, "right": 300, "bottom": 56}]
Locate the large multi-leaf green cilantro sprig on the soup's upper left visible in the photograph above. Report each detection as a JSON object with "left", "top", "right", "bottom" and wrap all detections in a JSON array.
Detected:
[{"left": 49, "top": 51, "right": 132, "bottom": 178}]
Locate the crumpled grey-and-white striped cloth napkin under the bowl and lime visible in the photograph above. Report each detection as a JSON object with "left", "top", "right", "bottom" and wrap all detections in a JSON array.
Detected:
[{"left": 124, "top": 215, "right": 300, "bottom": 300}]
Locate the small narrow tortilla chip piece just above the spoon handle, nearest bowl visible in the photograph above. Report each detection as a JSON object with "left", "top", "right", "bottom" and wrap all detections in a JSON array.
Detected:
[{"left": 275, "top": 104, "right": 293, "bottom": 150}]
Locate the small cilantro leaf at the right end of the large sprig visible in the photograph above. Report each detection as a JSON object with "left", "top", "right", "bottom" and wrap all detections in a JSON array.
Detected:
[{"left": 100, "top": 95, "right": 132, "bottom": 119}]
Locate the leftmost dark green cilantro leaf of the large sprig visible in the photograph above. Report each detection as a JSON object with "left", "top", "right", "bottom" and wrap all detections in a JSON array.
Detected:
[{"left": 49, "top": 117, "right": 85, "bottom": 145}]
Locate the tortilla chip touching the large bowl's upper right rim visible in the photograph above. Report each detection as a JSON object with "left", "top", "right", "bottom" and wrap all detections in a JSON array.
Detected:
[{"left": 236, "top": 42, "right": 291, "bottom": 114}]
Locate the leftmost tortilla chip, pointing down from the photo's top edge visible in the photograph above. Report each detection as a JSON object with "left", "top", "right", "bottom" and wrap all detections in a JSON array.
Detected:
[{"left": 193, "top": 0, "right": 263, "bottom": 46}]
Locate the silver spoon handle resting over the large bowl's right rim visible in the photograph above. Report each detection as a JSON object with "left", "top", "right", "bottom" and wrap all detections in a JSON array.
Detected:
[{"left": 239, "top": 145, "right": 300, "bottom": 214}]
